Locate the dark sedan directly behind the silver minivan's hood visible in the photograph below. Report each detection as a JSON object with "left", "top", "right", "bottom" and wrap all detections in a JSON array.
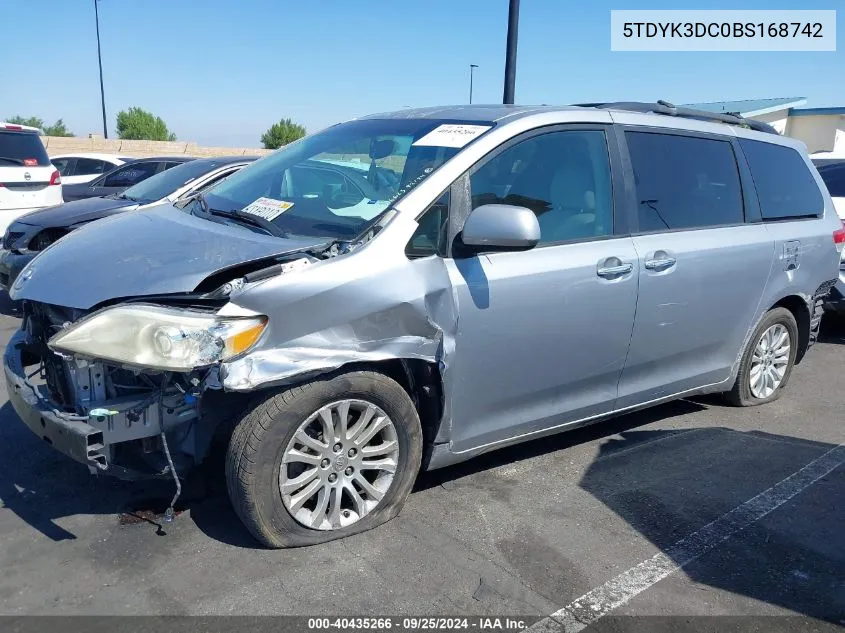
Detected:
[{"left": 0, "top": 156, "right": 255, "bottom": 290}]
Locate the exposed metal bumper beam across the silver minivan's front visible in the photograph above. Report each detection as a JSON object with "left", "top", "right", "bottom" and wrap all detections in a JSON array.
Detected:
[{"left": 3, "top": 331, "right": 108, "bottom": 473}]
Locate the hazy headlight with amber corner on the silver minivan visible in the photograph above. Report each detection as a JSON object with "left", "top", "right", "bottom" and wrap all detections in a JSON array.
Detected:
[{"left": 48, "top": 305, "right": 267, "bottom": 371}]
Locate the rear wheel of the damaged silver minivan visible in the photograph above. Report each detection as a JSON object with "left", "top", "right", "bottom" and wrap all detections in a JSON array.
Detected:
[{"left": 724, "top": 308, "right": 798, "bottom": 407}]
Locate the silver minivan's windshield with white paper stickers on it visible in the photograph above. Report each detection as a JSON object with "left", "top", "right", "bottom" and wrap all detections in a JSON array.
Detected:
[{"left": 206, "top": 119, "right": 492, "bottom": 240}]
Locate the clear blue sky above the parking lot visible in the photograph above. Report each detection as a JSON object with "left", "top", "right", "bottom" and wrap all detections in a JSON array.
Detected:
[{"left": 0, "top": 0, "right": 845, "bottom": 147}]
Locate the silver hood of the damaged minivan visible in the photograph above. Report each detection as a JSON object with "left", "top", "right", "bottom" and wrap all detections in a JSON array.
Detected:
[{"left": 10, "top": 204, "right": 327, "bottom": 310}]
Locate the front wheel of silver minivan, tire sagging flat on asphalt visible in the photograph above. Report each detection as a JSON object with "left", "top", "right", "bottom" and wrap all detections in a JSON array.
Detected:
[{"left": 226, "top": 371, "right": 422, "bottom": 547}]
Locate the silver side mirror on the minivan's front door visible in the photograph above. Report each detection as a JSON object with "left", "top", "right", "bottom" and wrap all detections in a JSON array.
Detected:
[{"left": 460, "top": 204, "right": 540, "bottom": 252}]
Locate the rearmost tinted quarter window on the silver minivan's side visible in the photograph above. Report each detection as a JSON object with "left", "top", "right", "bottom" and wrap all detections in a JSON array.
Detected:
[{"left": 739, "top": 139, "right": 824, "bottom": 220}]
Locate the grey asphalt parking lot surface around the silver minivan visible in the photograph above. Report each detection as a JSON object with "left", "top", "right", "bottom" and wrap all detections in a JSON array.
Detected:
[{"left": 0, "top": 304, "right": 845, "bottom": 623}]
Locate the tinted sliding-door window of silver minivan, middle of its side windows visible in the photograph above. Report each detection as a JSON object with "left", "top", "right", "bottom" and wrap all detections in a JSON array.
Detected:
[{"left": 625, "top": 132, "right": 744, "bottom": 232}]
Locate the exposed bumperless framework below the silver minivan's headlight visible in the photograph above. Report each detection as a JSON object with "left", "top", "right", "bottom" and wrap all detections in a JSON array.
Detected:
[{"left": 4, "top": 301, "right": 237, "bottom": 479}]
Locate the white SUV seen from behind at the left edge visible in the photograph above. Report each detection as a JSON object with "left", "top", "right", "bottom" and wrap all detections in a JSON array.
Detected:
[{"left": 0, "top": 123, "right": 62, "bottom": 231}]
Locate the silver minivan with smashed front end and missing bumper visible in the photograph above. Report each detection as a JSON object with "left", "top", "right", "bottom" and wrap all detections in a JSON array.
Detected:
[{"left": 5, "top": 103, "right": 845, "bottom": 547}]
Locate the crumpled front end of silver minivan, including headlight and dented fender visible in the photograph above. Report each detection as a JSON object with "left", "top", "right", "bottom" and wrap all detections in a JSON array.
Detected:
[{"left": 4, "top": 202, "right": 456, "bottom": 488}]
